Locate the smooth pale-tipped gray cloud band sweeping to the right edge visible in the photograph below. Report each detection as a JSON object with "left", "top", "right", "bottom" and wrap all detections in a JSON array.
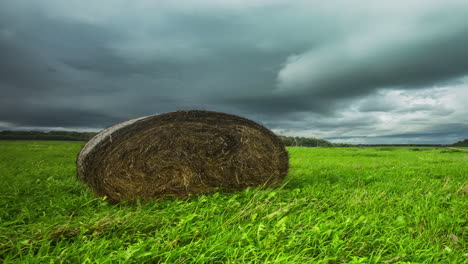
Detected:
[{"left": 278, "top": 18, "right": 468, "bottom": 98}]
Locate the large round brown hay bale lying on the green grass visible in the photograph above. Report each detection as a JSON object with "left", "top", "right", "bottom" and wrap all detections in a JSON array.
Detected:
[{"left": 77, "top": 110, "right": 288, "bottom": 202}]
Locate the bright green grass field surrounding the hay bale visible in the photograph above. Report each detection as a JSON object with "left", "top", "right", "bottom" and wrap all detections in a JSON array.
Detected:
[{"left": 0, "top": 141, "right": 468, "bottom": 263}]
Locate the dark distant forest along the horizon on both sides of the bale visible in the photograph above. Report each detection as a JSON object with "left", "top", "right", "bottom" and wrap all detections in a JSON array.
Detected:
[{"left": 0, "top": 130, "right": 462, "bottom": 147}]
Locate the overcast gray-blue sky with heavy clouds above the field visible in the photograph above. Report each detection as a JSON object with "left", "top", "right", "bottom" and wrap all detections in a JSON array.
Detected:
[{"left": 0, "top": 0, "right": 468, "bottom": 143}]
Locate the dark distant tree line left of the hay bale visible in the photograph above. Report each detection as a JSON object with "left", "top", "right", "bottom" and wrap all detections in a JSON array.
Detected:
[{"left": 0, "top": 130, "right": 96, "bottom": 141}]
